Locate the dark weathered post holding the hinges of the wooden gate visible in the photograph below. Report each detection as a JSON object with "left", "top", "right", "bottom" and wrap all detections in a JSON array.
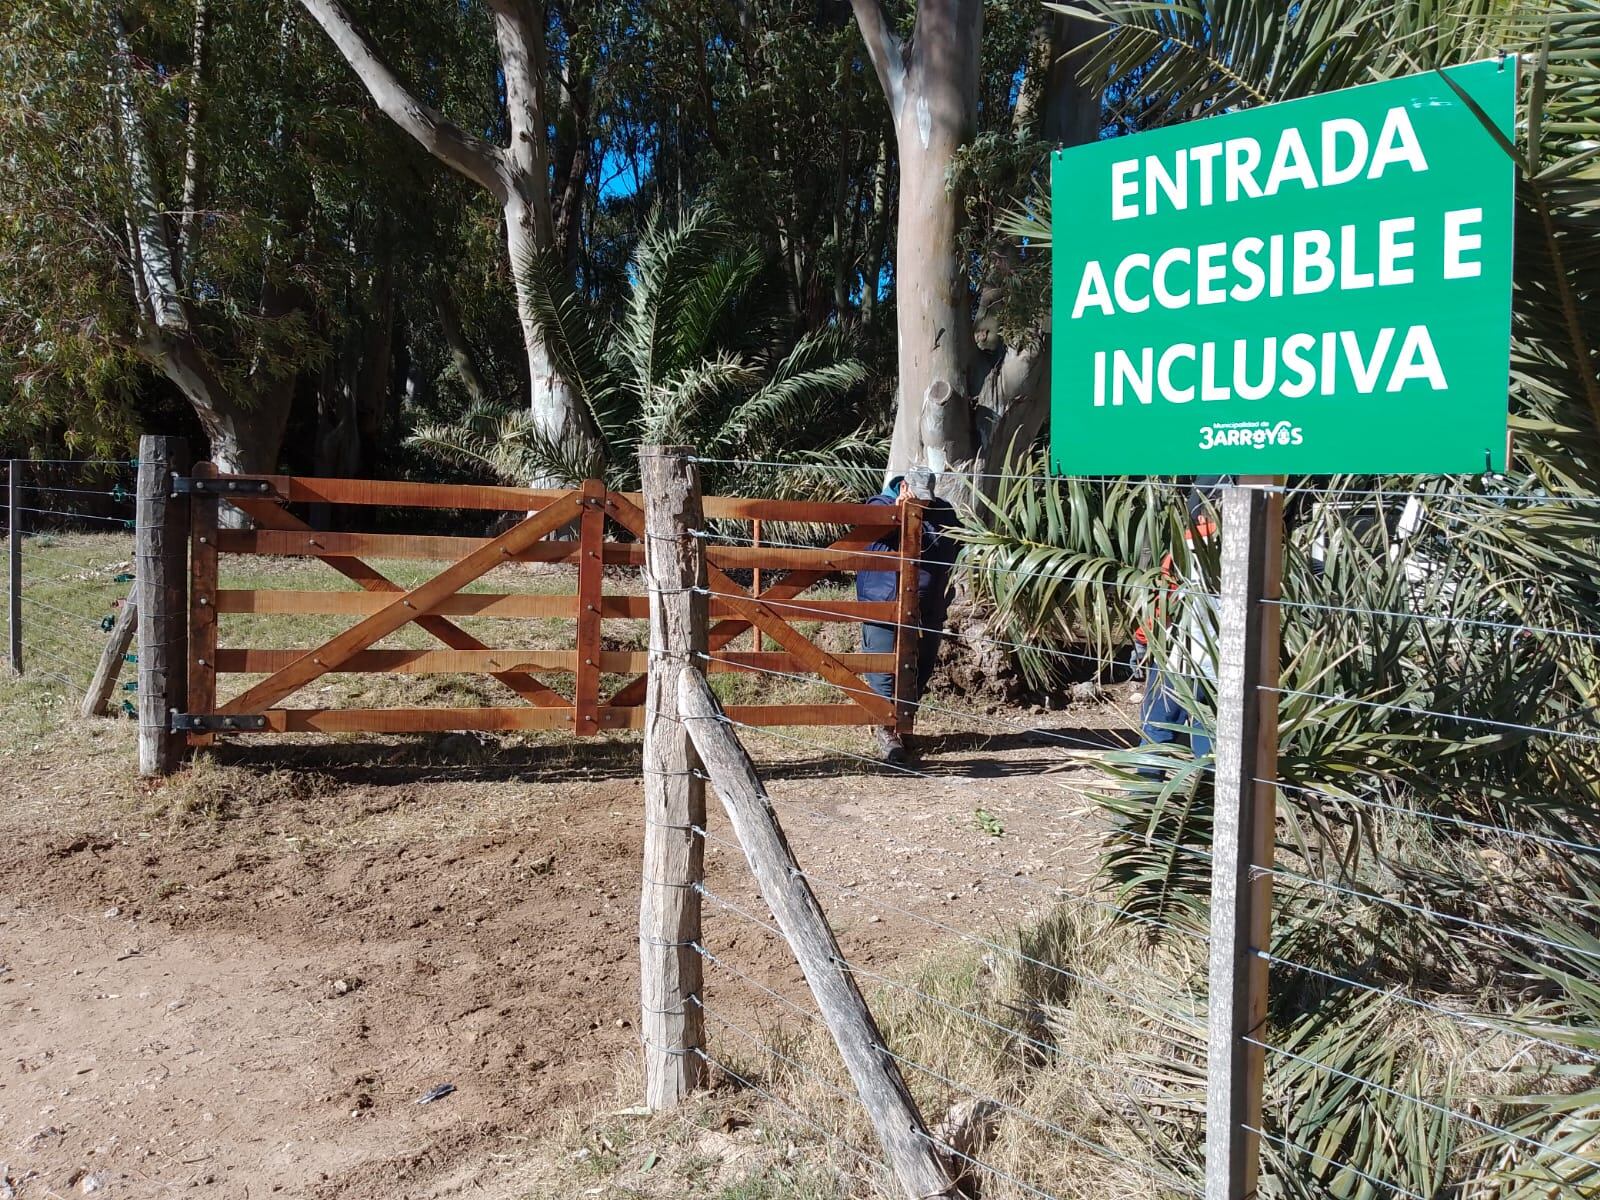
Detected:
[{"left": 133, "top": 435, "right": 189, "bottom": 776}]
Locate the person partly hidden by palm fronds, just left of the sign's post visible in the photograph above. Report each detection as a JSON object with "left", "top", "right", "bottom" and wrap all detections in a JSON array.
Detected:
[{"left": 1133, "top": 475, "right": 1226, "bottom": 764}]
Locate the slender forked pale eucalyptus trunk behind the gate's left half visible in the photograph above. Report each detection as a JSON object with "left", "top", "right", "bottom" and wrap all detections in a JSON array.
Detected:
[{"left": 301, "top": 0, "right": 598, "bottom": 486}]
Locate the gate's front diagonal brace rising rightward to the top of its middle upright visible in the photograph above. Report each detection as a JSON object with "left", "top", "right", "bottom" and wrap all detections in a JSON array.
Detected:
[{"left": 219, "top": 494, "right": 582, "bottom": 717}]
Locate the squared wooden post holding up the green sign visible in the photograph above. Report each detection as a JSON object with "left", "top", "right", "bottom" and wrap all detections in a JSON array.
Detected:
[{"left": 1205, "top": 485, "right": 1283, "bottom": 1200}]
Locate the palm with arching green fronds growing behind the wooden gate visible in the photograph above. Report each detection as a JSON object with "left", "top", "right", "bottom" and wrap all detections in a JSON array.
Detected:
[{"left": 411, "top": 205, "right": 886, "bottom": 490}]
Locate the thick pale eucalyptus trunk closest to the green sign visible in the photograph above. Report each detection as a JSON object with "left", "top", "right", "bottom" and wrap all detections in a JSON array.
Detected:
[{"left": 851, "top": 0, "right": 1098, "bottom": 493}]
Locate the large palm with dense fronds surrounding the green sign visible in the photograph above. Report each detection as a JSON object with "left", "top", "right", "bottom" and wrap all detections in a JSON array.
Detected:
[{"left": 965, "top": 0, "right": 1600, "bottom": 1200}]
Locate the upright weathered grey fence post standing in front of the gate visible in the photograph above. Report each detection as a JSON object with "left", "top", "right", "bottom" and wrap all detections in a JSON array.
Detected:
[{"left": 638, "top": 446, "right": 709, "bottom": 1109}]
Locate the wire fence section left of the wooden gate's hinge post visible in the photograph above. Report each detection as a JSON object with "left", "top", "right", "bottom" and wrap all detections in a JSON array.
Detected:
[{"left": 3, "top": 459, "right": 138, "bottom": 704}]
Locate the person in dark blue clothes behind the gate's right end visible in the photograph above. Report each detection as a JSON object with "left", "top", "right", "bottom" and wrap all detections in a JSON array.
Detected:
[{"left": 856, "top": 467, "right": 960, "bottom": 763}]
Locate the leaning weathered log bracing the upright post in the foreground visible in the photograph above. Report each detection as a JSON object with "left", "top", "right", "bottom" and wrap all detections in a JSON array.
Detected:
[{"left": 678, "top": 672, "right": 957, "bottom": 1200}]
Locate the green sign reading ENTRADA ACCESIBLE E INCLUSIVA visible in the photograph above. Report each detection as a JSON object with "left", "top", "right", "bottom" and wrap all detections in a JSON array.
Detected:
[{"left": 1051, "top": 58, "right": 1517, "bottom": 475}]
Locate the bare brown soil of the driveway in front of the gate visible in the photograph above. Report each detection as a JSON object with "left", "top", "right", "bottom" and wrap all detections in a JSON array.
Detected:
[{"left": 0, "top": 707, "right": 1128, "bottom": 1200}]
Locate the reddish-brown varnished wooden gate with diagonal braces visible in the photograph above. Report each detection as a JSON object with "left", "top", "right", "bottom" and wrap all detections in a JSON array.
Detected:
[{"left": 173, "top": 464, "right": 922, "bottom": 746}]
